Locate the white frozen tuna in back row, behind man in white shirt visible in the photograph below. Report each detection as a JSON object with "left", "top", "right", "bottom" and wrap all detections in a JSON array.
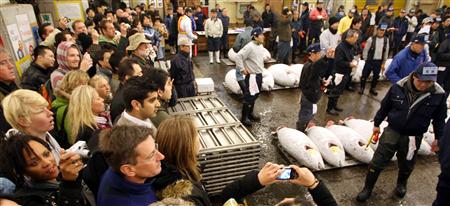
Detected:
[{"left": 224, "top": 64, "right": 303, "bottom": 94}]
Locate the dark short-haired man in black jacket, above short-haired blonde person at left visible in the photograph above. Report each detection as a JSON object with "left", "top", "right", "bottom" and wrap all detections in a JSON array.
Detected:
[{"left": 21, "top": 45, "right": 55, "bottom": 91}]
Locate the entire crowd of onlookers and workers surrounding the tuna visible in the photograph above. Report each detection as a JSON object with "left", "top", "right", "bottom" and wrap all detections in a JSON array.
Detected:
[{"left": 0, "top": 0, "right": 450, "bottom": 205}]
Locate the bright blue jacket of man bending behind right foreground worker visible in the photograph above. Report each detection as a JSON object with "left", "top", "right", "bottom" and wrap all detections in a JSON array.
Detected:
[{"left": 386, "top": 47, "right": 428, "bottom": 84}]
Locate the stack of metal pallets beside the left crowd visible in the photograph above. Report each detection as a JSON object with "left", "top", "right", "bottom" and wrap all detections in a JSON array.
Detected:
[{"left": 169, "top": 94, "right": 261, "bottom": 195}]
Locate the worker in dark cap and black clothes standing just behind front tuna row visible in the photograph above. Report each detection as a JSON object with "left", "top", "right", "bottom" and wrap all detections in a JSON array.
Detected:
[{"left": 297, "top": 43, "right": 332, "bottom": 132}]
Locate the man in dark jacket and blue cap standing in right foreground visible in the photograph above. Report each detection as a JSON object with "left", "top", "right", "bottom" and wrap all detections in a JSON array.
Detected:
[{"left": 356, "top": 62, "right": 447, "bottom": 202}]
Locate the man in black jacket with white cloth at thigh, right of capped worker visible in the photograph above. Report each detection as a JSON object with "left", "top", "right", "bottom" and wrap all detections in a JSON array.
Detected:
[{"left": 327, "top": 29, "right": 359, "bottom": 116}]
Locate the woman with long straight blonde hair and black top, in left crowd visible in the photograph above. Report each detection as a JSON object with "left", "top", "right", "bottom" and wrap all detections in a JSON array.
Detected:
[{"left": 67, "top": 85, "right": 111, "bottom": 144}]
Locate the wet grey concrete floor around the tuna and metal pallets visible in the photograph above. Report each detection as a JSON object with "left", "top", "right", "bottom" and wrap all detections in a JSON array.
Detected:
[{"left": 194, "top": 54, "right": 440, "bottom": 206}]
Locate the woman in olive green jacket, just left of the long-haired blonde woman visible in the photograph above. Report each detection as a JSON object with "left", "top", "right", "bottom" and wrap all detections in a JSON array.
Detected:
[{"left": 52, "top": 70, "right": 89, "bottom": 148}]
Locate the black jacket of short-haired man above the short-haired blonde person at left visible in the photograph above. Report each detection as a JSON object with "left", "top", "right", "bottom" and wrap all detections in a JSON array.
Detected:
[{"left": 21, "top": 62, "right": 52, "bottom": 91}]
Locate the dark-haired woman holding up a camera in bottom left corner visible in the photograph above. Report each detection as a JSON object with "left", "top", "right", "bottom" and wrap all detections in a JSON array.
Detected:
[{"left": 2, "top": 134, "right": 83, "bottom": 206}]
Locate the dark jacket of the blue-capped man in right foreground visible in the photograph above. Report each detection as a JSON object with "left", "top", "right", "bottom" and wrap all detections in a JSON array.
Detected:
[{"left": 374, "top": 74, "right": 447, "bottom": 139}]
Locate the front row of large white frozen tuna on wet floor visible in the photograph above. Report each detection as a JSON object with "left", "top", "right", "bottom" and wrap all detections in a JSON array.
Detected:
[{"left": 277, "top": 118, "right": 434, "bottom": 170}]
